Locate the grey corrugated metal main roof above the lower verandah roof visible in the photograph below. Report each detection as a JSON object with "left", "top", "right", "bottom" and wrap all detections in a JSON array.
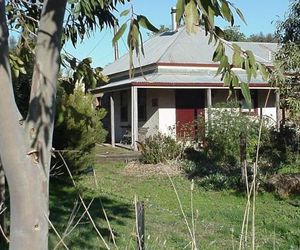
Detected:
[{"left": 103, "top": 27, "right": 278, "bottom": 75}]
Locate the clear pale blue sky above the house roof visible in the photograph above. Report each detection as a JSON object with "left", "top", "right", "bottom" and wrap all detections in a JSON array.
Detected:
[{"left": 65, "top": 0, "right": 290, "bottom": 67}]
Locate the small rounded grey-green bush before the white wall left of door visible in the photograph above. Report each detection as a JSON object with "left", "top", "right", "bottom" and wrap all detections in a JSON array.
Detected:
[{"left": 140, "top": 133, "right": 183, "bottom": 164}]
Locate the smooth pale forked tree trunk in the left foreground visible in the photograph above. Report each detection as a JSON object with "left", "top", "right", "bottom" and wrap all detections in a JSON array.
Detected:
[{"left": 0, "top": 0, "right": 66, "bottom": 250}]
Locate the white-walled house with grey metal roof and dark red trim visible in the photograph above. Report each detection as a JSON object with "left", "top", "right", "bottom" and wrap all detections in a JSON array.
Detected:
[{"left": 92, "top": 10, "right": 279, "bottom": 149}]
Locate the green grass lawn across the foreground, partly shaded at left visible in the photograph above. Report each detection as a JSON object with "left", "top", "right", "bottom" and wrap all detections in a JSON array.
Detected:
[{"left": 50, "top": 163, "right": 300, "bottom": 249}]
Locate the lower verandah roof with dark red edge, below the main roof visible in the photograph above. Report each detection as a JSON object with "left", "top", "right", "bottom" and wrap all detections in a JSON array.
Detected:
[{"left": 91, "top": 68, "right": 274, "bottom": 94}]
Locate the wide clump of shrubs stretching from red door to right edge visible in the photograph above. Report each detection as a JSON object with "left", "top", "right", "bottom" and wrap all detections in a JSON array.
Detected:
[{"left": 183, "top": 103, "right": 299, "bottom": 189}]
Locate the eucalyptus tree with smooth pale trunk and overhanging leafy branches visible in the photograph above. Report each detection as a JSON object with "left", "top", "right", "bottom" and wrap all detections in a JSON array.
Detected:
[{"left": 0, "top": 0, "right": 268, "bottom": 250}]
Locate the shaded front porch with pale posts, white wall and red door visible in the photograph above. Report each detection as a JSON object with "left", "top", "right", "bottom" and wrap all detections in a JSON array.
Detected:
[{"left": 107, "top": 86, "right": 280, "bottom": 150}]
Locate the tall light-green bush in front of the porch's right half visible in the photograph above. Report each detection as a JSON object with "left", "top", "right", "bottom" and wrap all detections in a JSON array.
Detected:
[{"left": 205, "top": 102, "right": 269, "bottom": 172}]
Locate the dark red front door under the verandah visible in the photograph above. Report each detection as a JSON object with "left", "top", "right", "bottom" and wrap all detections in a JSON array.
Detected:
[{"left": 175, "top": 89, "right": 205, "bottom": 137}]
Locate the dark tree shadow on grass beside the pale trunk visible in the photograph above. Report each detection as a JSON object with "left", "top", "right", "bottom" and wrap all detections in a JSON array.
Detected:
[{"left": 49, "top": 179, "right": 134, "bottom": 249}]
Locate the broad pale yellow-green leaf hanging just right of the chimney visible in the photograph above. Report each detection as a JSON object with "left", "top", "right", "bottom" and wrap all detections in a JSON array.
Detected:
[{"left": 184, "top": 0, "right": 200, "bottom": 34}]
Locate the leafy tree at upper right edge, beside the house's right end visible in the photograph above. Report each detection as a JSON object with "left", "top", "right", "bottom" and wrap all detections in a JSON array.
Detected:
[{"left": 272, "top": 1, "right": 300, "bottom": 126}]
